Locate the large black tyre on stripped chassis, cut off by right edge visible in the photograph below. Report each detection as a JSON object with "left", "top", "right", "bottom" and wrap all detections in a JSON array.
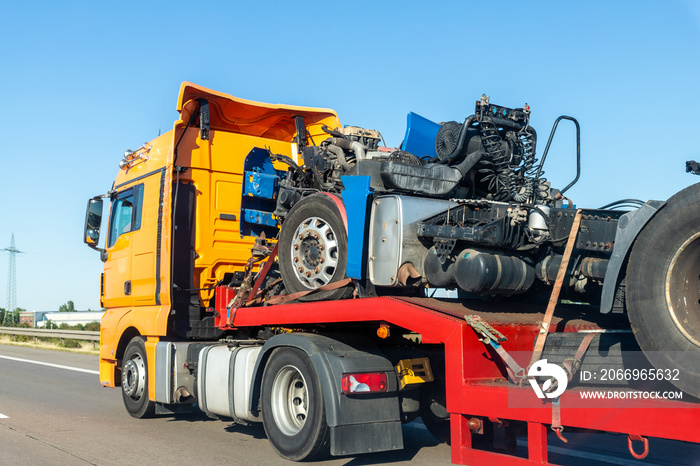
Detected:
[{"left": 627, "top": 184, "right": 700, "bottom": 398}]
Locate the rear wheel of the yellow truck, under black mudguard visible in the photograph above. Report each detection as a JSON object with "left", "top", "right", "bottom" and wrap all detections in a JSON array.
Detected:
[{"left": 262, "top": 348, "right": 330, "bottom": 461}]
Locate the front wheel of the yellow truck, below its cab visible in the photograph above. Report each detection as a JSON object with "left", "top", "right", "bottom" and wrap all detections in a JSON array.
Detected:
[{"left": 122, "top": 337, "right": 156, "bottom": 419}]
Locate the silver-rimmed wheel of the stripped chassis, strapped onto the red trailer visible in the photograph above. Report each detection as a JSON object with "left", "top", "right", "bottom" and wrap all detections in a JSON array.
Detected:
[{"left": 279, "top": 194, "right": 352, "bottom": 301}]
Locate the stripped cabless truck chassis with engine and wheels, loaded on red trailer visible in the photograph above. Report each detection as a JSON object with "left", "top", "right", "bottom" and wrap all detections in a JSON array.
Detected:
[{"left": 262, "top": 96, "right": 700, "bottom": 393}]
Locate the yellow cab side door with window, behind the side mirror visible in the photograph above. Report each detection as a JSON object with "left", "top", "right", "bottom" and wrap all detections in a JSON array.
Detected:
[{"left": 103, "top": 184, "right": 143, "bottom": 308}]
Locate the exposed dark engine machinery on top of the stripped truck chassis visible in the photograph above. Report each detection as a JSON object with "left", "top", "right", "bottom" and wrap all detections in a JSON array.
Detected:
[{"left": 278, "top": 96, "right": 552, "bottom": 204}]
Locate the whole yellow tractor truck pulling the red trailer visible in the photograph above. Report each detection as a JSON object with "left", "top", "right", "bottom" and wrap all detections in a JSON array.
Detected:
[{"left": 85, "top": 83, "right": 416, "bottom": 459}]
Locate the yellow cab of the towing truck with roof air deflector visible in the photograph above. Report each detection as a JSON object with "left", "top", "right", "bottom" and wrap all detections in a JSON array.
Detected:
[{"left": 85, "top": 82, "right": 340, "bottom": 390}]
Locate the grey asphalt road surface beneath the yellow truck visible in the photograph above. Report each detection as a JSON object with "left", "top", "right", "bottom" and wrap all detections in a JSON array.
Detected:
[{"left": 0, "top": 345, "right": 700, "bottom": 466}]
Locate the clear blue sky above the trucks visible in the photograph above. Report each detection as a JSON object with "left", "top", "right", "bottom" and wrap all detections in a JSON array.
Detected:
[{"left": 0, "top": 0, "right": 700, "bottom": 311}]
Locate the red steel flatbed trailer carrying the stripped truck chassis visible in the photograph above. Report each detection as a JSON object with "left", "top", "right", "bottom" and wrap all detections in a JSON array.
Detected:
[{"left": 234, "top": 297, "right": 700, "bottom": 465}]
